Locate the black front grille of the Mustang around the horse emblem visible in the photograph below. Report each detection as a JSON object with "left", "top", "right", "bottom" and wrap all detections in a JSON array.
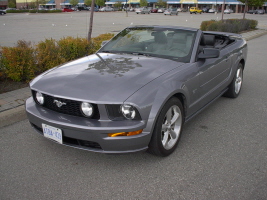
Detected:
[{"left": 32, "top": 90, "right": 100, "bottom": 119}]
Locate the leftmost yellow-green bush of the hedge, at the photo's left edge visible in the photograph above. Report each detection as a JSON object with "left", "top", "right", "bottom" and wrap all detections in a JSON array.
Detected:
[{"left": 1, "top": 40, "right": 36, "bottom": 82}]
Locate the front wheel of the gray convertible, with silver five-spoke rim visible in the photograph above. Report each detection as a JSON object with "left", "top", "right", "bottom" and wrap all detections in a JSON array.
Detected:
[{"left": 148, "top": 97, "right": 184, "bottom": 157}]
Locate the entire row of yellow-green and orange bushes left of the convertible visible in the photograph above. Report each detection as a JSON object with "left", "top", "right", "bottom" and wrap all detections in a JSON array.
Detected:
[{"left": 0, "top": 33, "right": 114, "bottom": 82}]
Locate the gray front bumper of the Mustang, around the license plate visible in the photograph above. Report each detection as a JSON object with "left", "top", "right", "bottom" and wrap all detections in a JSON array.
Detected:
[{"left": 25, "top": 97, "right": 151, "bottom": 153}]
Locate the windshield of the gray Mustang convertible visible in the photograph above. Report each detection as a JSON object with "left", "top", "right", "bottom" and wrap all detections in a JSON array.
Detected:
[{"left": 98, "top": 27, "right": 196, "bottom": 62}]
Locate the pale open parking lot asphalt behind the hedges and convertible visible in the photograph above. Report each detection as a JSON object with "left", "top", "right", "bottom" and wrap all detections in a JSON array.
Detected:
[{"left": 0, "top": 11, "right": 267, "bottom": 46}]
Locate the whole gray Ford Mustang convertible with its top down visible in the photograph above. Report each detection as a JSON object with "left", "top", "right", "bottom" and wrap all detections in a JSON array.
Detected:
[{"left": 26, "top": 26, "right": 247, "bottom": 156}]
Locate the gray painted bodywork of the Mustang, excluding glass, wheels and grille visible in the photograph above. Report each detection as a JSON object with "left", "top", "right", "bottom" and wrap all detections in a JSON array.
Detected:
[{"left": 26, "top": 26, "right": 247, "bottom": 153}]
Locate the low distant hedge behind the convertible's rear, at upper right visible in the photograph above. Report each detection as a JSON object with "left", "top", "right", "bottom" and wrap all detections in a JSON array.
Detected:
[{"left": 200, "top": 19, "right": 258, "bottom": 33}]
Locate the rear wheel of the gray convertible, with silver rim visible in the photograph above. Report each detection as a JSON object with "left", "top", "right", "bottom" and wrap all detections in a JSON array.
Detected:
[{"left": 224, "top": 63, "right": 244, "bottom": 98}]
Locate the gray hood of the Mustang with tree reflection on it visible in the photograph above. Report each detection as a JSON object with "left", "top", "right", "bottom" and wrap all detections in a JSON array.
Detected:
[{"left": 30, "top": 53, "right": 184, "bottom": 103}]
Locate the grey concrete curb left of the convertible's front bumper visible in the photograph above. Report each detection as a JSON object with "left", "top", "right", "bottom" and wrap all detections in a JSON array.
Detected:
[{"left": 0, "top": 105, "right": 27, "bottom": 128}]
